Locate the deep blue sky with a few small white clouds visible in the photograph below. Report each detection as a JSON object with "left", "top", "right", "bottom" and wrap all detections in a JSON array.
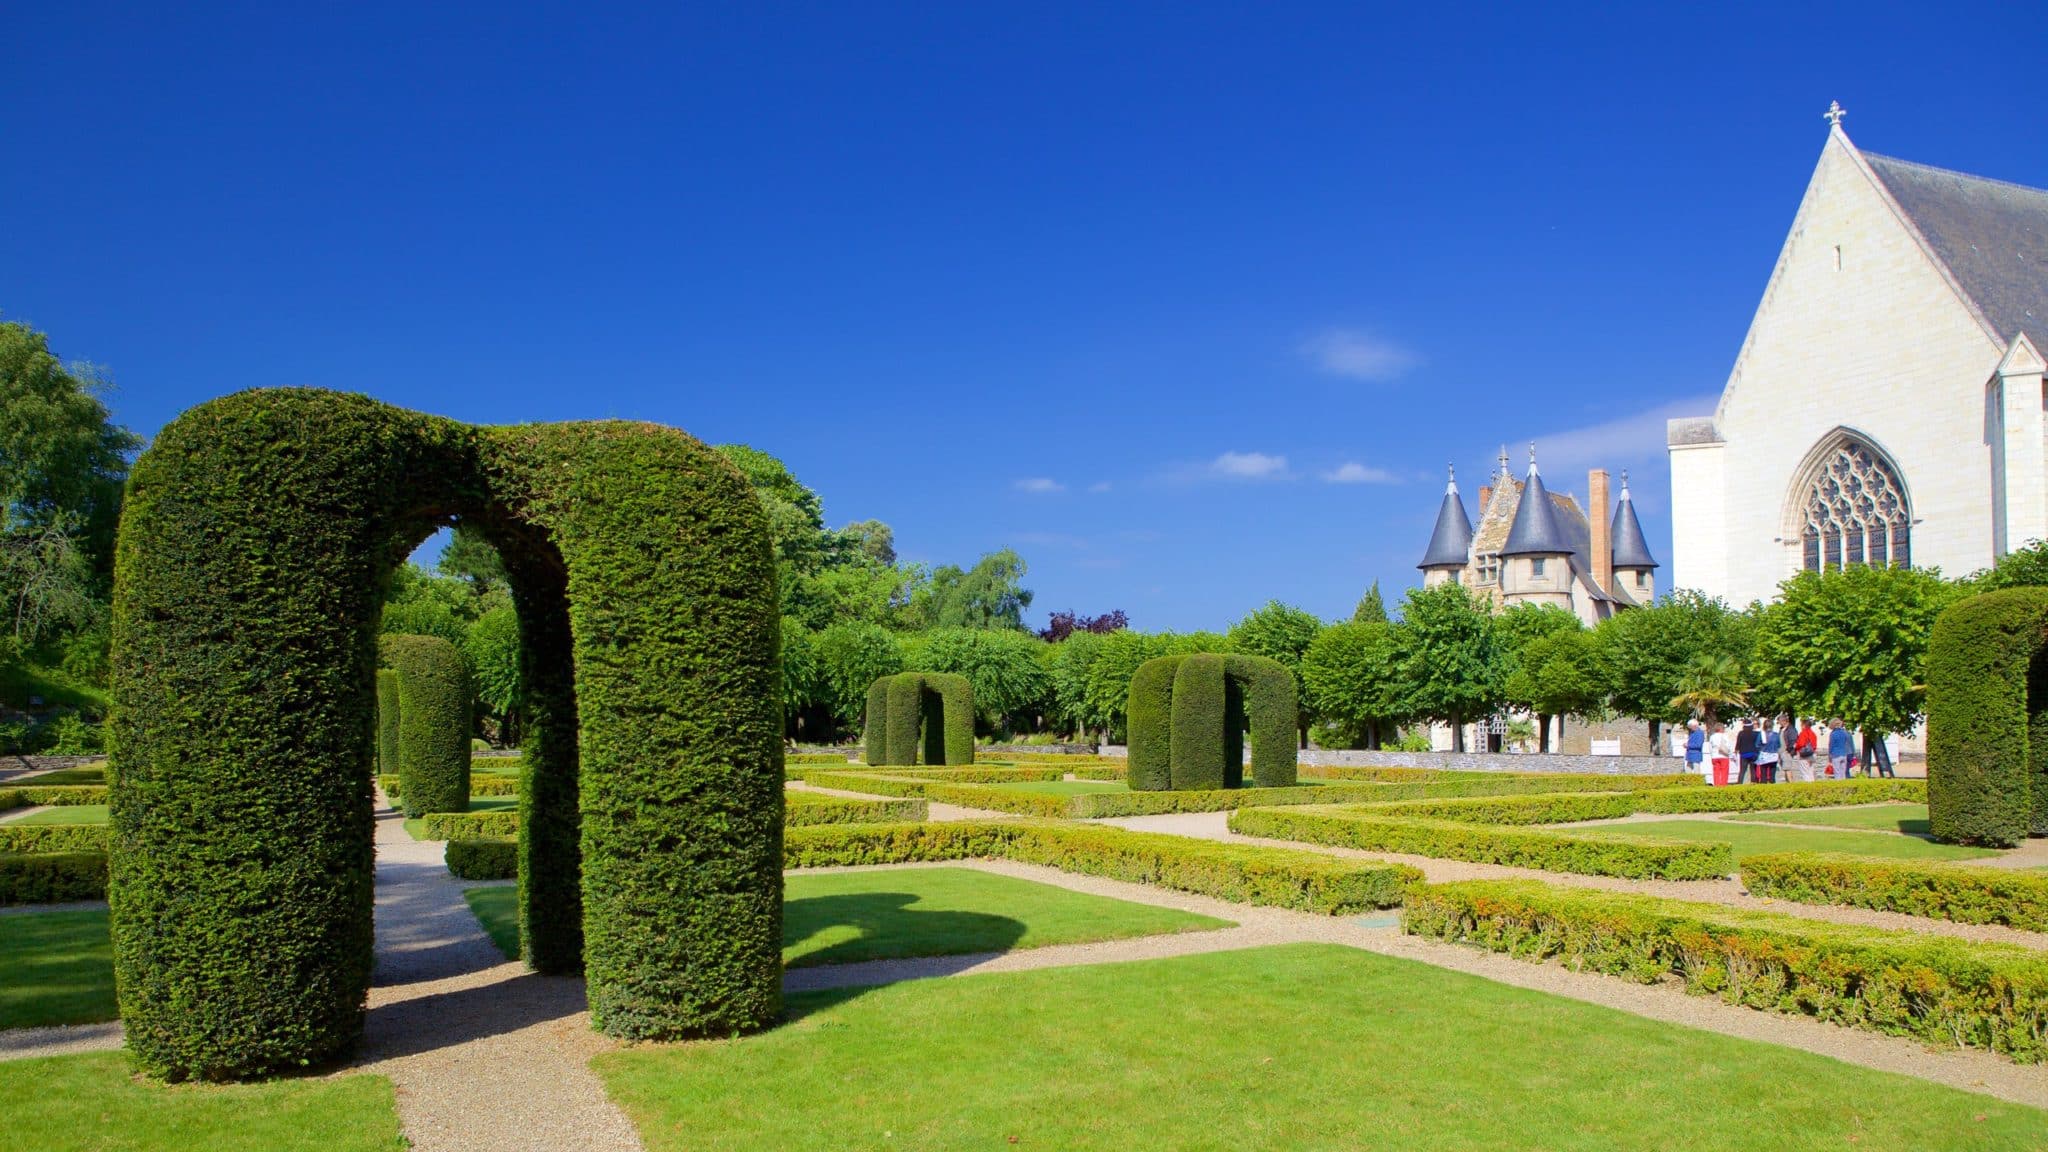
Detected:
[{"left": 0, "top": 2, "right": 2048, "bottom": 629}]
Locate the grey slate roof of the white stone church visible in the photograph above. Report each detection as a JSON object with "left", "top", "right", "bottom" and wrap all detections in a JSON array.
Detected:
[{"left": 1864, "top": 152, "right": 2048, "bottom": 346}]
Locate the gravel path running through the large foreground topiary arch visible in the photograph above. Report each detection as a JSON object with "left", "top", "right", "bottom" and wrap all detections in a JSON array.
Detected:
[{"left": 356, "top": 787, "right": 641, "bottom": 1152}]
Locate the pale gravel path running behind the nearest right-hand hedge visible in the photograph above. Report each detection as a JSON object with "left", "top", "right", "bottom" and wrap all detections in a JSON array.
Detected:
[{"left": 1100, "top": 812, "right": 2048, "bottom": 949}]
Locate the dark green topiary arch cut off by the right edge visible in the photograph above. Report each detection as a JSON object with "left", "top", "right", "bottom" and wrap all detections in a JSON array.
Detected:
[{"left": 1927, "top": 588, "right": 2048, "bottom": 847}]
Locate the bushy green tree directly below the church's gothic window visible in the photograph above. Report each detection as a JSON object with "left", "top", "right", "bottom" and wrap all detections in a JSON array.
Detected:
[{"left": 1751, "top": 564, "right": 1957, "bottom": 734}]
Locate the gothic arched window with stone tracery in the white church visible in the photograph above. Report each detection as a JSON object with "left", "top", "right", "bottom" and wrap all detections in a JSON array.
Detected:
[{"left": 1796, "top": 435, "right": 1913, "bottom": 572}]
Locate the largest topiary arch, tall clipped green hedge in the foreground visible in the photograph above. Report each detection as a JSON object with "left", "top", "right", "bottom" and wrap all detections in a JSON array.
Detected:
[{"left": 109, "top": 389, "right": 782, "bottom": 1078}]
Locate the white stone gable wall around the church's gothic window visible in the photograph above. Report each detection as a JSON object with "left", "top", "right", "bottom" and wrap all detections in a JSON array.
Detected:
[{"left": 1671, "top": 135, "right": 2005, "bottom": 605}]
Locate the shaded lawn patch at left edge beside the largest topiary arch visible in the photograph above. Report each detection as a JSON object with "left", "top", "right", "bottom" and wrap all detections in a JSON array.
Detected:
[{"left": 0, "top": 910, "right": 117, "bottom": 1024}]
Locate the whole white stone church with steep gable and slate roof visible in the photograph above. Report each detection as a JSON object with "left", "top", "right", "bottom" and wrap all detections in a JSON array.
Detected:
[{"left": 1667, "top": 107, "right": 2048, "bottom": 605}]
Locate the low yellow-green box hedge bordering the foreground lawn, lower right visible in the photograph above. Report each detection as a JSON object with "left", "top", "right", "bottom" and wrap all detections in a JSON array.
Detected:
[{"left": 1401, "top": 881, "right": 2048, "bottom": 1064}]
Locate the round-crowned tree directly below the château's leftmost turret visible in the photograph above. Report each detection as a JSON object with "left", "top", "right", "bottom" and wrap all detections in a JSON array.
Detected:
[{"left": 1395, "top": 584, "right": 1503, "bottom": 752}]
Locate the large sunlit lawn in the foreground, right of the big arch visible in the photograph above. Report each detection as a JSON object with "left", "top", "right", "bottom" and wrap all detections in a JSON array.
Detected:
[{"left": 594, "top": 945, "right": 2048, "bottom": 1152}]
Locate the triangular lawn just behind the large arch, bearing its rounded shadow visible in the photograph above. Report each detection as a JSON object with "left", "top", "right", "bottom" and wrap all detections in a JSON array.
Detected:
[{"left": 465, "top": 867, "right": 1231, "bottom": 968}]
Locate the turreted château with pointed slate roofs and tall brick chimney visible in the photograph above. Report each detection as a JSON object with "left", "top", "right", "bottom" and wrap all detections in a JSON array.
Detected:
[{"left": 1417, "top": 447, "right": 1657, "bottom": 627}]
